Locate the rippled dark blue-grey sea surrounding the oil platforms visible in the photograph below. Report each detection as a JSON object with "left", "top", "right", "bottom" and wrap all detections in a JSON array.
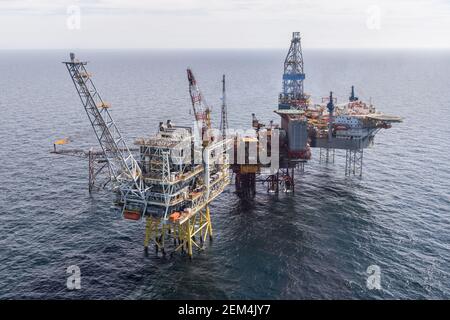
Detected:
[{"left": 0, "top": 49, "right": 450, "bottom": 299}]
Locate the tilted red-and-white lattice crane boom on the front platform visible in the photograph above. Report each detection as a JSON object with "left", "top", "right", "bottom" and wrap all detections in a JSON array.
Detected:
[{"left": 187, "top": 69, "right": 211, "bottom": 146}]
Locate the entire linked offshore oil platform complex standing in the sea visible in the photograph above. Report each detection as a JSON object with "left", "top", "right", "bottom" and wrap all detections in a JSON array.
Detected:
[{"left": 52, "top": 32, "right": 401, "bottom": 257}]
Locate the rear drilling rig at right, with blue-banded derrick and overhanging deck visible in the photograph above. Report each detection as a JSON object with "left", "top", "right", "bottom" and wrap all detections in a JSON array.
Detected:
[{"left": 232, "top": 32, "right": 402, "bottom": 197}]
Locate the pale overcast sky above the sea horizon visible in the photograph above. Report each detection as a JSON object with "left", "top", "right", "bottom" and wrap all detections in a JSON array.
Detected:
[{"left": 0, "top": 0, "right": 450, "bottom": 49}]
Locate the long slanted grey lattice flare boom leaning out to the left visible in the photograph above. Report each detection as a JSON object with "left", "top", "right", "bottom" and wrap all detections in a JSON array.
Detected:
[{"left": 64, "top": 53, "right": 145, "bottom": 201}]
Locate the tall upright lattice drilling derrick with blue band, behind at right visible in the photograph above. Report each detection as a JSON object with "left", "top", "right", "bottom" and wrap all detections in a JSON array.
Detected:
[{"left": 278, "top": 32, "right": 309, "bottom": 109}]
